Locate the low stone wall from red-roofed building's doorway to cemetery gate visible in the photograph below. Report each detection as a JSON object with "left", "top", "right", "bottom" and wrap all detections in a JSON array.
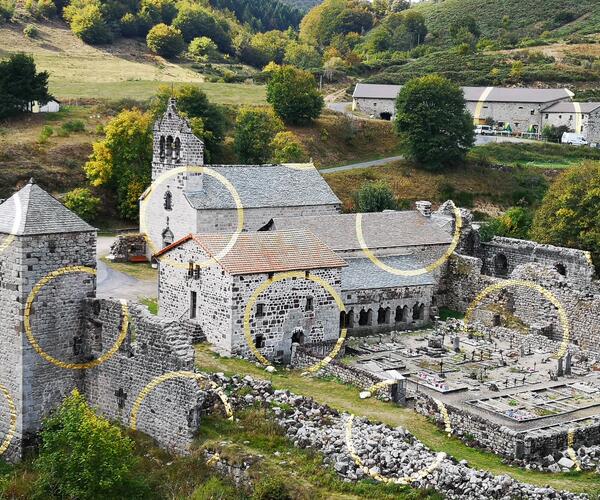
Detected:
[{"left": 290, "top": 344, "right": 404, "bottom": 400}]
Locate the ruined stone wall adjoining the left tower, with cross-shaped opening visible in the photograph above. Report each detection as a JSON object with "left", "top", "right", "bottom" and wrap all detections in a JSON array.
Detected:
[{"left": 83, "top": 300, "right": 207, "bottom": 454}]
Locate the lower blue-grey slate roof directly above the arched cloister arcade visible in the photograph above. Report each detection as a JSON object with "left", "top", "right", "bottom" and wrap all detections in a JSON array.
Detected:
[{"left": 342, "top": 255, "right": 435, "bottom": 292}]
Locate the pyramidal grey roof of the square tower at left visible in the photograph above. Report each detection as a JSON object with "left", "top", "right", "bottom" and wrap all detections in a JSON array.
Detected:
[{"left": 0, "top": 179, "right": 96, "bottom": 236}]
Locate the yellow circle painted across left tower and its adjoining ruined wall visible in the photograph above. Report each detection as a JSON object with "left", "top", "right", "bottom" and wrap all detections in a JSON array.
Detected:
[{"left": 24, "top": 266, "right": 129, "bottom": 370}]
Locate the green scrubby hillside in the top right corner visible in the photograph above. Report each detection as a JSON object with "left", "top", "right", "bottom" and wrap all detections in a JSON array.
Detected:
[{"left": 413, "top": 0, "right": 600, "bottom": 39}]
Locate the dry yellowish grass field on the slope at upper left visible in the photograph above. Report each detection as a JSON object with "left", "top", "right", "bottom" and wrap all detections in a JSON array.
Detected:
[{"left": 0, "top": 21, "right": 265, "bottom": 104}]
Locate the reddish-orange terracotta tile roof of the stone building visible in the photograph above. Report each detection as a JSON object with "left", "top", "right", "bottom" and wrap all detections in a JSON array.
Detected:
[{"left": 156, "top": 230, "right": 346, "bottom": 275}]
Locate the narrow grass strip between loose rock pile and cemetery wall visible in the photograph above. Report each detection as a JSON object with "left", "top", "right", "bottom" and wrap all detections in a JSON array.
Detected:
[{"left": 196, "top": 345, "right": 600, "bottom": 497}]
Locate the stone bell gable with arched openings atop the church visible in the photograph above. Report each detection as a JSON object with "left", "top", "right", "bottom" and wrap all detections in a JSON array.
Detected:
[{"left": 152, "top": 98, "right": 204, "bottom": 181}]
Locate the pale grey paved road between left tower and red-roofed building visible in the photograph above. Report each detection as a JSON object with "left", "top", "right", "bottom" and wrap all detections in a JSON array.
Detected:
[{"left": 97, "top": 236, "right": 158, "bottom": 300}]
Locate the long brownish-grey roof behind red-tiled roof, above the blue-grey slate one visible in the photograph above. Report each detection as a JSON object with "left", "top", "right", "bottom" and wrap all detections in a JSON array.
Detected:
[{"left": 273, "top": 211, "right": 452, "bottom": 251}]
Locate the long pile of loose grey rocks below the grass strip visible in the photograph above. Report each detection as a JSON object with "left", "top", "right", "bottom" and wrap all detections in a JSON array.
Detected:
[{"left": 205, "top": 374, "right": 587, "bottom": 500}]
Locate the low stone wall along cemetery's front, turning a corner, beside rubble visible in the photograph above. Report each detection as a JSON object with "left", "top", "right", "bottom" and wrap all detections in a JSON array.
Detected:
[{"left": 415, "top": 392, "right": 600, "bottom": 463}]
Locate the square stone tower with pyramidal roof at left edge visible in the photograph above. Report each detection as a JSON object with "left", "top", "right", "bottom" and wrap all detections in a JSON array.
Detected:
[{"left": 0, "top": 180, "right": 96, "bottom": 461}]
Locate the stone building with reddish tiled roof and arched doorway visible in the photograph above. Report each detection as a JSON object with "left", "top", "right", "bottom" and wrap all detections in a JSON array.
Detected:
[{"left": 155, "top": 230, "right": 346, "bottom": 362}]
